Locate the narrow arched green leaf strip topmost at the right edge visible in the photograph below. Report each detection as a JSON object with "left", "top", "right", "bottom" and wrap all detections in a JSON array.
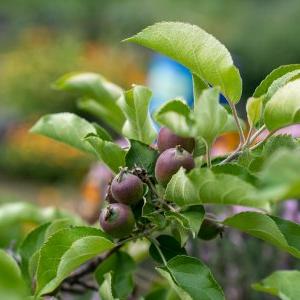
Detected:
[{"left": 253, "top": 64, "right": 300, "bottom": 98}]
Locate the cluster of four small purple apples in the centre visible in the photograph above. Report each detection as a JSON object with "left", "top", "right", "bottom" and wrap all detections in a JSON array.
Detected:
[{"left": 100, "top": 128, "right": 195, "bottom": 238}]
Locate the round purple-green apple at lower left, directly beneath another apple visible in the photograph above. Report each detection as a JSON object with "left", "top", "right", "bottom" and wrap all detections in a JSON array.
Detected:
[{"left": 99, "top": 203, "right": 135, "bottom": 238}]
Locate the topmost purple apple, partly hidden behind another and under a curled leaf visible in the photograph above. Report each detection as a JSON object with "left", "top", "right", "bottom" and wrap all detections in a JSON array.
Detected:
[{"left": 157, "top": 127, "right": 195, "bottom": 153}]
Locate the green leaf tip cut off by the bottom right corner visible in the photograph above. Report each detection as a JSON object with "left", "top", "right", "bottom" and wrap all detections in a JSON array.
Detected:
[{"left": 252, "top": 271, "right": 300, "bottom": 300}]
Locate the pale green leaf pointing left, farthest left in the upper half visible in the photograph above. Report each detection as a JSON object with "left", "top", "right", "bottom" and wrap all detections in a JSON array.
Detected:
[{"left": 30, "top": 113, "right": 96, "bottom": 154}]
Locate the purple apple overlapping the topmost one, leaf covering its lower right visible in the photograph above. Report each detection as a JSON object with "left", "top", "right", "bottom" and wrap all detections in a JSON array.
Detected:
[{"left": 155, "top": 147, "right": 195, "bottom": 186}]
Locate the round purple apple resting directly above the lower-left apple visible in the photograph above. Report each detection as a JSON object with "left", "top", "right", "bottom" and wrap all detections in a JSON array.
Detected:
[{"left": 111, "top": 171, "right": 144, "bottom": 205}]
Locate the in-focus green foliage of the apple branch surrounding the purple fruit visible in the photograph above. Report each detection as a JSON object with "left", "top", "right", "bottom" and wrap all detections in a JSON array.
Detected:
[{"left": 0, "top": 22, "right": 300, "bottom": 300}]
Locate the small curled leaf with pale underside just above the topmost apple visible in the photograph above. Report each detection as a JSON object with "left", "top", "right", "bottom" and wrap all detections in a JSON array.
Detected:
[{"left": 154, "top": 99, "right": 193, "bottom": 137}]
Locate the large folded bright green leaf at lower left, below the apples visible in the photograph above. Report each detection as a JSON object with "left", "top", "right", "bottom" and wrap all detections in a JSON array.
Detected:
[{"left": 36, "top": 227, "right": 114, "bottom": 296}]
